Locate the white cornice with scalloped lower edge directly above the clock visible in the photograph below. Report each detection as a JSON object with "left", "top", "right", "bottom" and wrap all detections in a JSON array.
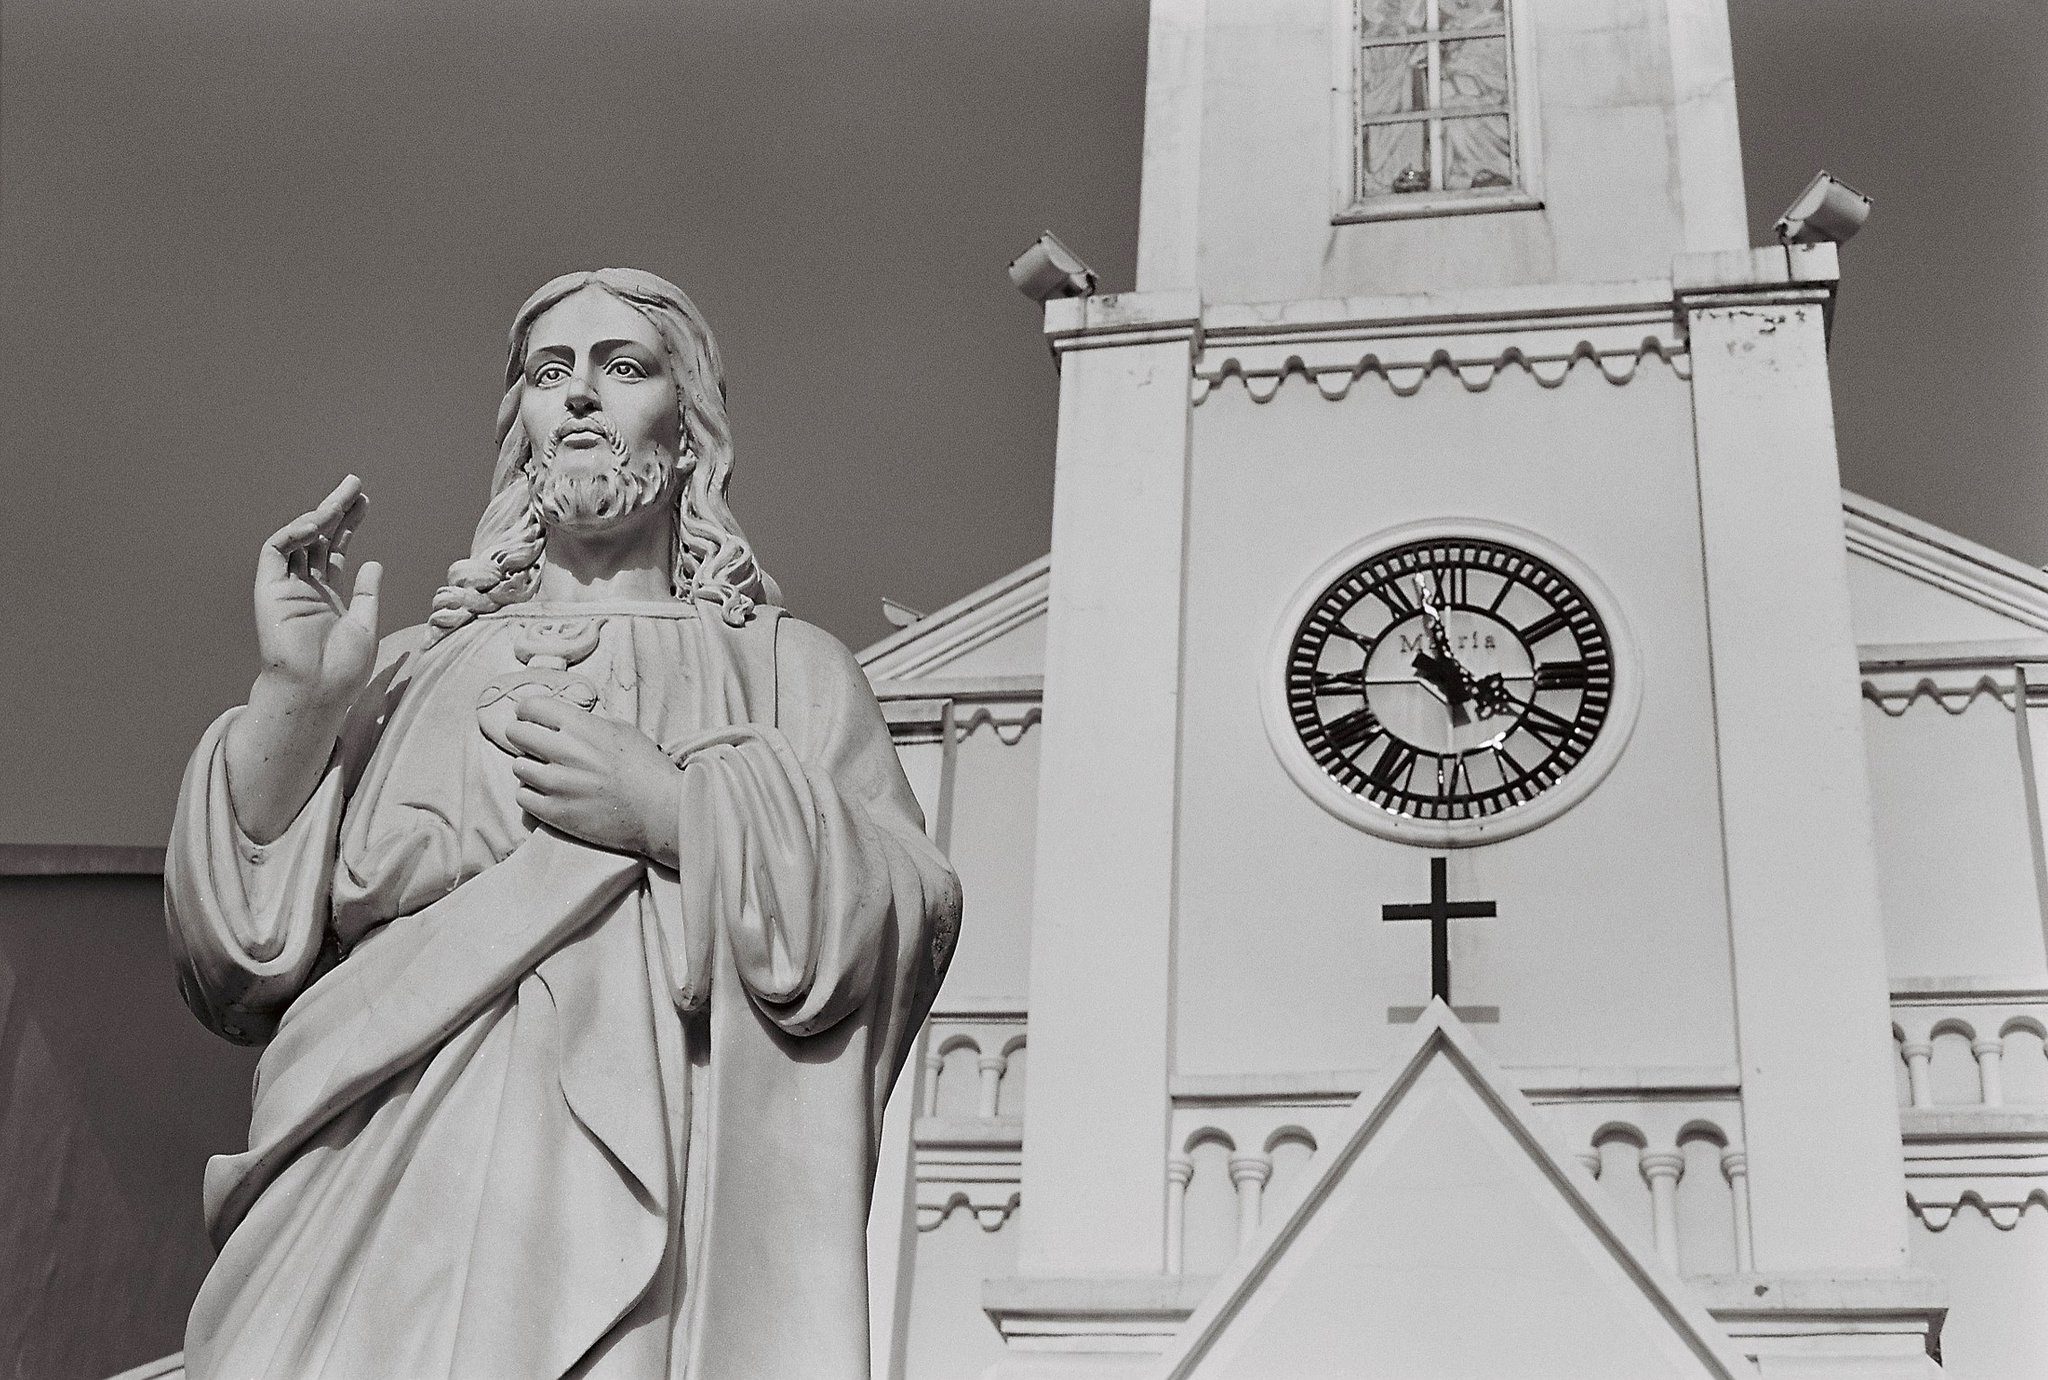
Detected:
[{"left": 1192, "top": 283, "right": 1692, "bottom": 403}]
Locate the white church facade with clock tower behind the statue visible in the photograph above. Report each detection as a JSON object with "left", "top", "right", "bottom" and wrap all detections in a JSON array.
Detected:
[{"left": 862, "top": 0, "right": 2048, "bottom": 1380}]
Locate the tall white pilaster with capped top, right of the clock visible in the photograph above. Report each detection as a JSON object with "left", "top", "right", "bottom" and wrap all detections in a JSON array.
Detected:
[{"left": 1673, "top": 246, "right": 1905, "bottom": 1271}]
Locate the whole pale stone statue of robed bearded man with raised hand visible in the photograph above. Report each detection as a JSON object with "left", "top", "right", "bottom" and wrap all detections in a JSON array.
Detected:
[{"left": 166, "top": 268, "right": 961, "bottom": 1380}]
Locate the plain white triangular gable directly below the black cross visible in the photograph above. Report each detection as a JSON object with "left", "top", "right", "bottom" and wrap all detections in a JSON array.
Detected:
[{"left": 1157, "top": 1001, "right": 1755, "bottom": 1380}]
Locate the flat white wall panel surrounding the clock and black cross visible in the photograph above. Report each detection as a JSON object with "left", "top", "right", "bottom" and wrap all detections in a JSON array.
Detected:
[{"left": 1176, "top": 362, "right": 1735, "bottom": 1073}]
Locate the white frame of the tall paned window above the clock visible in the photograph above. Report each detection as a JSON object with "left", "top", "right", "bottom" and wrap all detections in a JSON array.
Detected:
[{"left": 1329, "top": 0, "right": 1542, "bottom": 225}]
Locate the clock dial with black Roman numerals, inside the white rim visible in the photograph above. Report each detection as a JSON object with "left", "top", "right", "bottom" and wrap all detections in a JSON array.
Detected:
[{"left": 1286, "top": 538, "right": 1614, "bottom": 819}]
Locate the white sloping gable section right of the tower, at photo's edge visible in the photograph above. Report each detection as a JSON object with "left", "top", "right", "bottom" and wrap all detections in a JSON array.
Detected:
[{"left": 1841, "top": 491, "right": 2048, "bottom": 647}]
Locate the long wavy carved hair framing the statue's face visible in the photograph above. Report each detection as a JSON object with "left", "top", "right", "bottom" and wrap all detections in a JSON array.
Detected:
[{"left": 426, "top": 268, "right": 780, "bottom": 645}]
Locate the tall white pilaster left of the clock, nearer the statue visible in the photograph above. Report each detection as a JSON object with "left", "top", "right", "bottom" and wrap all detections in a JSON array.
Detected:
[{"left": 1018, "top": 293, "right": 1198, "bottom": 1276}]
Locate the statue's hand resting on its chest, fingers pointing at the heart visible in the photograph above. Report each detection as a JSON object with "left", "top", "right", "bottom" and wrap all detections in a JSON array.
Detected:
[{"left": 506, "top": 694, "right": 682, "bottom": 868}]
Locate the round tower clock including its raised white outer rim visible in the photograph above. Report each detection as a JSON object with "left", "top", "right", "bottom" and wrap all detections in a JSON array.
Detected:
[{"left": 1266, "top": 522, "right": 1634, "bottom": 846}]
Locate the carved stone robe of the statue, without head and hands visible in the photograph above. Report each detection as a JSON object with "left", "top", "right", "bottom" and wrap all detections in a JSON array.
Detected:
[{"left": 166, "top": 602, "right": 961, "bottom": 1380}]
